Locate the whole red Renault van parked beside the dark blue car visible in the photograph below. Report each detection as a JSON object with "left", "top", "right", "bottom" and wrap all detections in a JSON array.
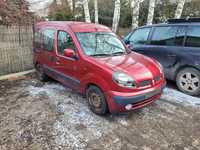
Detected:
[{"left": 33, "top": 21, "right": 165, "bottom": 115}]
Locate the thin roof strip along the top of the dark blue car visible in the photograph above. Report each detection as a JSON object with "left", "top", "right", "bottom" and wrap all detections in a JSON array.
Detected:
[{"left": 138, "top": 22, "right": 200, "bottom": 29}]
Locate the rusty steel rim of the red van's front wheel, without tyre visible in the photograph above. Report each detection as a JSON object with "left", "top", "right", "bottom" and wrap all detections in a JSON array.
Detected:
[{"left": 89, "top": 92, "right": 101, "bottom": 108}]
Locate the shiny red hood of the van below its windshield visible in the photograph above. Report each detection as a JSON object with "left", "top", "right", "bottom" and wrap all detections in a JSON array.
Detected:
[{"left": 91, "top": 52, "right": 160, "bottom": 80}]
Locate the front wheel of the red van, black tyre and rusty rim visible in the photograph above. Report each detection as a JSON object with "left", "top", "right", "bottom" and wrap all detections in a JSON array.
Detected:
[{"left": 86, "top": 86, "right": 108, "bottom": 115}]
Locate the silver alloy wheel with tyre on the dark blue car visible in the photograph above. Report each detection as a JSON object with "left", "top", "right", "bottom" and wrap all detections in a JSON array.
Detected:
[{"left": 176, "top": 68, "right": 200, "bottom": 96}]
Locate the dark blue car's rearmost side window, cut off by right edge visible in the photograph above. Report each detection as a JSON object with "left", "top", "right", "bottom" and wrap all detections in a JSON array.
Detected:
[{"left": 185, "top": 26, "right": 200, "bottom": 47}]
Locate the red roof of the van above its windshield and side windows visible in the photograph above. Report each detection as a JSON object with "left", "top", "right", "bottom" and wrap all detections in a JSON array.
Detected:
[{"left": 36, "top": 21, "right": 112, "bottom": 32}]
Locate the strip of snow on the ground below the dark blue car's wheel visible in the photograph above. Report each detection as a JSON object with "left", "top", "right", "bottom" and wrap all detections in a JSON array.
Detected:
[{"left": 161, "top": 88, "right": 200, "bottom": 106}]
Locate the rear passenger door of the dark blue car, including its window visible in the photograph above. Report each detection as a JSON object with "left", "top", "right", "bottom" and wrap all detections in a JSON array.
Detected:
[{"left": 149, "top": 25, "right": 186, "bottom": 70}]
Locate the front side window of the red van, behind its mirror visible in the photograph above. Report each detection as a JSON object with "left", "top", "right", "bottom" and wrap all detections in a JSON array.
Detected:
[{"left": 58, "top": 31, "right": 76, "bottom": 55}]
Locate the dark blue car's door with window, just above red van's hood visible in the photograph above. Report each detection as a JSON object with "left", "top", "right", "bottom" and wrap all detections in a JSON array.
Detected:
[{"left": 147, "top": 26, "right": 182, "bottom": 70}]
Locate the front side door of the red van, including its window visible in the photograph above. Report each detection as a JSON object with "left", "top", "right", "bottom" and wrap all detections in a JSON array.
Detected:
[{"left": 54, "top": 30, "right": 80, "bottom": 90}]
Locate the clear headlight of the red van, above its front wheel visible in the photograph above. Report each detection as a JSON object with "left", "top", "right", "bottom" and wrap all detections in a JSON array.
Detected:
[{"left": 113, "top": 72, "right": 136, "bottom": 88}]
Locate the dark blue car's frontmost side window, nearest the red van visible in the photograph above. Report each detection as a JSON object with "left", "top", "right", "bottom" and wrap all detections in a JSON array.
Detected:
[{"left": 129, "top": 28, "right": 151, "bottom": 45}]
